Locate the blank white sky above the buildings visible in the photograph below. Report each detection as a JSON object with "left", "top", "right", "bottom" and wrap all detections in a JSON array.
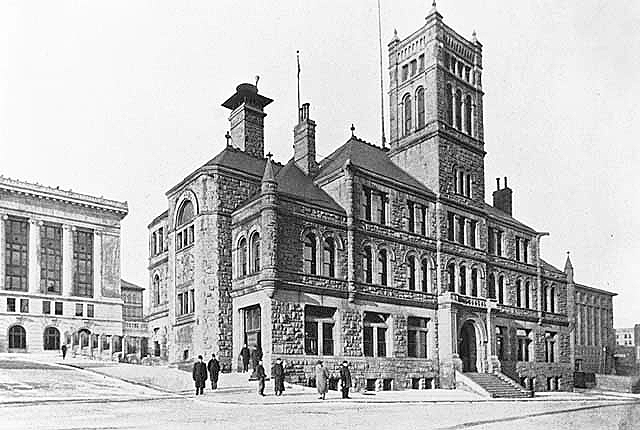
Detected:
[{"left": 0, "top": 0, "right": 640, "bottom": 326}]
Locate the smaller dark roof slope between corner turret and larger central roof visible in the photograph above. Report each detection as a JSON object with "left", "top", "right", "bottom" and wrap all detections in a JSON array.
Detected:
[{"left": 276, "top": 159, "right": 344, "bottom": 213}]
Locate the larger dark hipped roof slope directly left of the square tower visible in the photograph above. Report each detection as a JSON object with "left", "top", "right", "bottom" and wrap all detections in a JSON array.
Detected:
[{"left": 316, "top": 136, "right": 435, "bottom": 195}]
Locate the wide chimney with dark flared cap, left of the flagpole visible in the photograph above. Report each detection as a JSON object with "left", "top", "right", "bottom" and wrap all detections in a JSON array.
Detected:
[{"left": 222, "top": 84, "right": 273, "bottom": 158}]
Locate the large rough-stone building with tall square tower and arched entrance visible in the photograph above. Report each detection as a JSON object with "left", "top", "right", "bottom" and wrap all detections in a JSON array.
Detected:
[{"left": 148, "top": 8, "right": 610, "bottom": 390}]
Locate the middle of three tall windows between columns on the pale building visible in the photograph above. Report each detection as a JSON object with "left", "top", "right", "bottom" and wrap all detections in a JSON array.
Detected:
[{"left": 40, "top": 224, "right": 62, "bottom": 294}]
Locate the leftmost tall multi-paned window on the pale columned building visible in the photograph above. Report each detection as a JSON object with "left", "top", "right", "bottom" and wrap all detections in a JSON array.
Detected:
[{"left": 4, "top": 218, "right": 29, "bottom": 291}]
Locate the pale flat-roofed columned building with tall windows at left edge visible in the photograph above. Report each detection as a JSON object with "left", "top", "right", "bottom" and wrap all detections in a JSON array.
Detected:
[{"left": 0, "top": 173, "right": 136, "bottom": 355}]
